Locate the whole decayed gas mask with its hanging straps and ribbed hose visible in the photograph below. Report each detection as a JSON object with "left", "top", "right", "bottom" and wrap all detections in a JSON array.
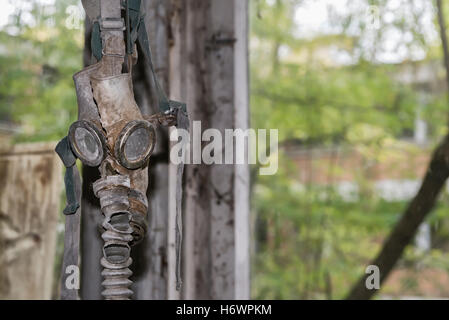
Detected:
[{"left": 56, "top": 0, "right": 188, "bottom": 299}]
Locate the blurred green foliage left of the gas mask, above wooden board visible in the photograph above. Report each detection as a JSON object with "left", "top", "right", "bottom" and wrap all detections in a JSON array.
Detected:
[{"left": 0, "top": 0, "right": 84, "bottom": 141}]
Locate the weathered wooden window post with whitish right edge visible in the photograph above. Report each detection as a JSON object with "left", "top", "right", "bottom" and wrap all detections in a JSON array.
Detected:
[{"left": 169, "top": 0, "right": 249, "bottom": 299}]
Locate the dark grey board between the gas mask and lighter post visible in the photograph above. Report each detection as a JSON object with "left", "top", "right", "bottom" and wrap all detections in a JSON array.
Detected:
[{"left": 132, "top": 0, "right": 169, "bottom": 300}]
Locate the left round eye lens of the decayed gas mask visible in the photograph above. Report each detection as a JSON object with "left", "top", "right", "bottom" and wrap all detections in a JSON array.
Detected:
[{"left": 69, "top": 120, "right": 104, "bottom": 167}]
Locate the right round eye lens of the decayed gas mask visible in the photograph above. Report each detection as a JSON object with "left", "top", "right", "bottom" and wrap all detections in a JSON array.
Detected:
[{"left": 115, "top": 120, "right": 156, "bottom": 169}]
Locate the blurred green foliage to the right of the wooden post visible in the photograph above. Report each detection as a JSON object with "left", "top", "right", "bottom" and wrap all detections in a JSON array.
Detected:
[{"left": 250, "top": 0, "right": 449, "bottom": 299}]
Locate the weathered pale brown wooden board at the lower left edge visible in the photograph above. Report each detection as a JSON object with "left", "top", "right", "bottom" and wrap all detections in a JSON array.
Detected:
[{"left": 0, "top": 143, "right": 63, "bottom": 299}]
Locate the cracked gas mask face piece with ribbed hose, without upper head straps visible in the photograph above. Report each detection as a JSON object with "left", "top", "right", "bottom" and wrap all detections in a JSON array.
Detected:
[{"left": 58, "top": 40, "right": 156, "bottom": 299}]
